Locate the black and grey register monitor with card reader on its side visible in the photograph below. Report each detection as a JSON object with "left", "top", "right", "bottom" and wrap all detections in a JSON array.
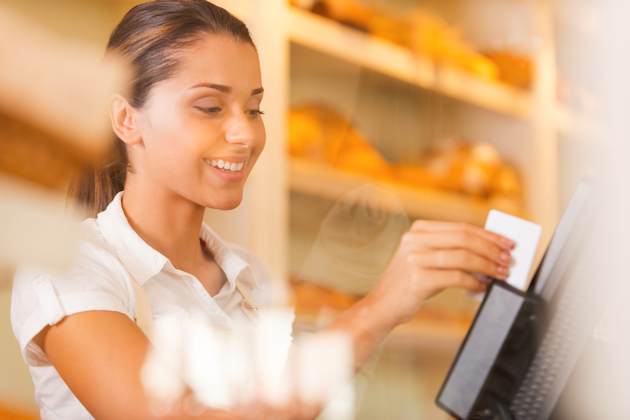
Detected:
[{"left": 436, "top": 179, "right": 606, "bottom": 420}]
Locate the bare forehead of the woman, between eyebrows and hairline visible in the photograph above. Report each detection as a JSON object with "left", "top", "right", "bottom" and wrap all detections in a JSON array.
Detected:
[{"left": 176, "top": 34, "right": 262, "bottom": 94}]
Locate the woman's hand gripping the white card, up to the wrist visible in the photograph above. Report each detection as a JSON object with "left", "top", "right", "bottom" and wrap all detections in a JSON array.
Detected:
[{"left": 370, "top": 220, "right": 514, "bottom": 325}]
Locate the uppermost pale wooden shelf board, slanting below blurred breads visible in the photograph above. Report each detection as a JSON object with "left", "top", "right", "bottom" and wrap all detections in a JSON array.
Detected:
[{"left": 288, "top": 8, "right": 532, "bottom": 119}]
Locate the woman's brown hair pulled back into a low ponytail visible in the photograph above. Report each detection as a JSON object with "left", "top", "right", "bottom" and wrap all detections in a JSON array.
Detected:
[{"left": 69, "top": 0, "right": 256, "bottom": 215}]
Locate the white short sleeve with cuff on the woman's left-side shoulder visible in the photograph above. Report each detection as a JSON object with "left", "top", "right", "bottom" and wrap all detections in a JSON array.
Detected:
[{"left": 11, "top": 233, "right": 133, "bottom": 367}]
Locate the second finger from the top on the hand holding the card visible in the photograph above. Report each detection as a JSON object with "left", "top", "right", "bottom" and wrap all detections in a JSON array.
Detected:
[{"left": 405, "top": 230, "right": 512, "bottom": 267}]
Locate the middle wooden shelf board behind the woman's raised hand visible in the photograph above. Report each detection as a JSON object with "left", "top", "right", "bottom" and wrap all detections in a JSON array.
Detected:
[{"left": 289, "top": 158, "right": 527, "bottom": 226}]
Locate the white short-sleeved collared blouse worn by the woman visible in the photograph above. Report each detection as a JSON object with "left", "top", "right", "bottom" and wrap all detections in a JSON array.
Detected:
[{"left": 11, "top": 192, "right": 271, "bottom": 420}]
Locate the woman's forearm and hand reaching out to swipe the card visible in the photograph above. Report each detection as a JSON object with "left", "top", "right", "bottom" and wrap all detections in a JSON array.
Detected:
[{"left": 325, "top": 221, "right": 514, "bottom": 371}]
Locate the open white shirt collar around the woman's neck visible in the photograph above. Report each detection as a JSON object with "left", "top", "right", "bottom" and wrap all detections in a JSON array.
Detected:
[{"left": 96, "top": 191, "right": 261, "bottom": 291}]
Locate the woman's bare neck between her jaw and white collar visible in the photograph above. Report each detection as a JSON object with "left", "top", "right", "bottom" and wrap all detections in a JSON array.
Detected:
[{"left": 122, "top": 174, "right": 205, "bottom": 272}]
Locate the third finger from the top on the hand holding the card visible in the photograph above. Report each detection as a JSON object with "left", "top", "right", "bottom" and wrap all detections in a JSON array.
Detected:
[{"left": 410, "top": 249, "right": 510, "bottom": 280}]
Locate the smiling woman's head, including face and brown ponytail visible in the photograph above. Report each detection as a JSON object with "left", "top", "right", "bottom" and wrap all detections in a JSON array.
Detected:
[{"left": 73, "top": 1, "right": 265, "bottom": 214}]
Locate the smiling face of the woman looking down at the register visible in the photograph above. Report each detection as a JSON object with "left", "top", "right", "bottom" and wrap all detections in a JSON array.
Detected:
[{"left": 131, "top": 35, "right": 265, "bottom": 210}]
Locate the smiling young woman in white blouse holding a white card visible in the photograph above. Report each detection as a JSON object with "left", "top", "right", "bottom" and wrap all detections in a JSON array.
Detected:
[{"left": 11, "top": 0, "right": 513, "bottom": 420}]
